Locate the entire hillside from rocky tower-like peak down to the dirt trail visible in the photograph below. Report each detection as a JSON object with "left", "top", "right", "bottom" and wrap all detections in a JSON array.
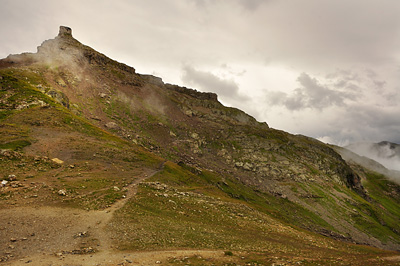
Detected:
[{"left": 0, "top": 27, "right": 400, "bottom": 265}]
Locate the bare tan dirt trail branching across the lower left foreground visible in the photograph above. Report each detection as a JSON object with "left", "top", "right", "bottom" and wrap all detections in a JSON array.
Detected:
[{"left": 0, "top": 163, "right": 228, "bottom": 266}]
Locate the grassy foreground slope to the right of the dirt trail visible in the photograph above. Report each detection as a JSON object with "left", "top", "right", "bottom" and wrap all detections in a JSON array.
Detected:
[{"left": 109, "top": 163, "right": 400, "bottom": 265}]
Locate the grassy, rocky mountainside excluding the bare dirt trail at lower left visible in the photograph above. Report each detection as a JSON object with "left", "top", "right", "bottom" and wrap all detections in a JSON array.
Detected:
[{"left": 0, "top": 27, "right": 400, "bottom": 264}]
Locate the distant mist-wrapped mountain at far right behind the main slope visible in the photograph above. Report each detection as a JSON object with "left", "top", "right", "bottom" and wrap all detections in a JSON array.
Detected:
[{"left": 345, "top": 141, "right": 400, "bottom": 171}]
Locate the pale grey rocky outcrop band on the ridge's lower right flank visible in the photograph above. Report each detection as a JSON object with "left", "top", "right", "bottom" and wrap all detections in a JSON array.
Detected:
[{"left": 181, "top": 121, "right": 365, "bottom": 196}]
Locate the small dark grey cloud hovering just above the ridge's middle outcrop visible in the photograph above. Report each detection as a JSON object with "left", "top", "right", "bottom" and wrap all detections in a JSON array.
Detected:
[{"left": 182, "top": 65, "right": 249, "bottom": 101}]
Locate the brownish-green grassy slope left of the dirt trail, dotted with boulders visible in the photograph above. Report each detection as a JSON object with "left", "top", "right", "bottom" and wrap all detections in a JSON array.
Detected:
[{"left": 0, "top": 66, "right": 161, "bottom": 209}]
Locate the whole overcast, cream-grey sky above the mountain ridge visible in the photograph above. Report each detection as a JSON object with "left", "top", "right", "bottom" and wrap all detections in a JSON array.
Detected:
[{"left": 0, "top": 0, "right": 400, "bottom": 145}]
